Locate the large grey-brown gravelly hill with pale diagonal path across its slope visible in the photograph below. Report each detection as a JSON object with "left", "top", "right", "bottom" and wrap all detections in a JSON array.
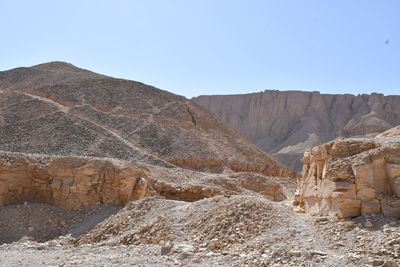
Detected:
[{"left": 0, "top": 62, "right": 292, "bottom": 176}]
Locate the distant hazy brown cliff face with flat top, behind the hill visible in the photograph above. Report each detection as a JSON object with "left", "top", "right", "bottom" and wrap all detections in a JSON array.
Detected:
[{"left": 192, "top": 90, "right": 400, "bottom": 171}]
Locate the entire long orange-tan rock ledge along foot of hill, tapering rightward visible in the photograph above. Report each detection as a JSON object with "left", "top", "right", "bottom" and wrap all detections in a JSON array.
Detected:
[{"left": 0, "top": 152, "right": 285, "bottom": 209}]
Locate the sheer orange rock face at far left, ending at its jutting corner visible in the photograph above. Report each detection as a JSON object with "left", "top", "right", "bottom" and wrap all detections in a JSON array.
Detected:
[{"left": 0, "top": 154, "right": 156, "bottom": 208}]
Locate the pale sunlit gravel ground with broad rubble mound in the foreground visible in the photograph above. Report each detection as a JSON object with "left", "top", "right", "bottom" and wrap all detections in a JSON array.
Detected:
[{"left": 0, "top": 195, "right": 400, "bottom": 267}]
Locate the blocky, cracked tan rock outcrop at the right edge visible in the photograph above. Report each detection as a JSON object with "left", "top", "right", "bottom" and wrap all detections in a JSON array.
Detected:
[{"left": 298, "top": 128, "right": 400, "bottom": 218}]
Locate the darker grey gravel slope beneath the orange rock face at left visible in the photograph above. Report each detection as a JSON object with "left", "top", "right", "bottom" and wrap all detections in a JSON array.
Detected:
[{"left": 0, "top": 202, "right": 121, "bottom": 244}]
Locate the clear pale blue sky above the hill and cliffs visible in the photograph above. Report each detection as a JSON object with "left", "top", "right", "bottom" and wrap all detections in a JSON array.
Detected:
[{"left": 0, "top": 0, "right": 400, "bottom": 97}]
